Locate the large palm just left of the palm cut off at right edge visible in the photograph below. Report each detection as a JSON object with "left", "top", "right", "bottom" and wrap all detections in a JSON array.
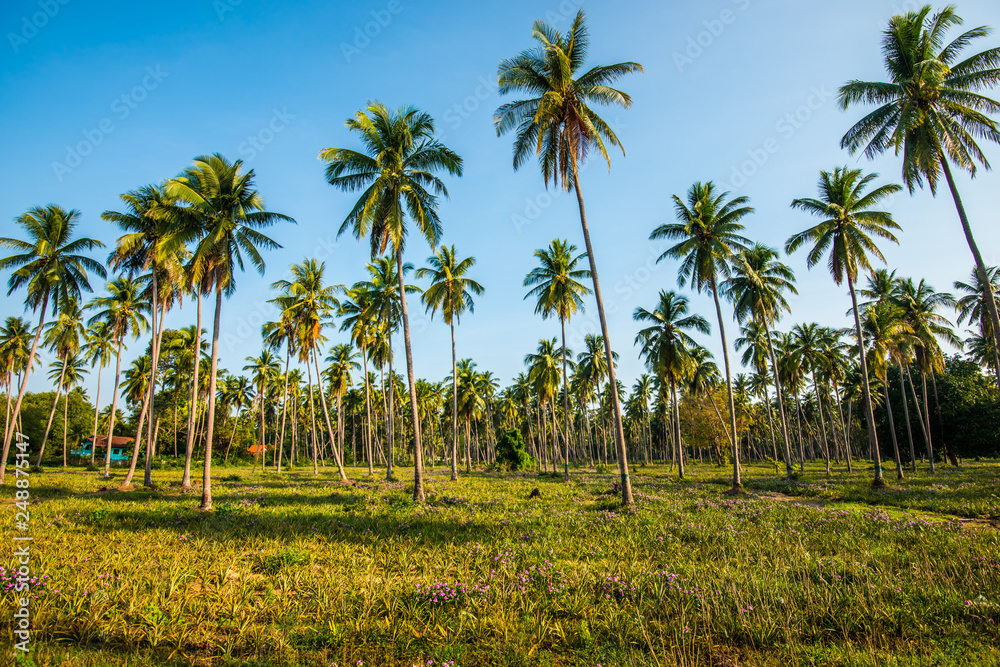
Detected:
[{"left": 785, "top": 167, "right": 903, "bottom": 487}]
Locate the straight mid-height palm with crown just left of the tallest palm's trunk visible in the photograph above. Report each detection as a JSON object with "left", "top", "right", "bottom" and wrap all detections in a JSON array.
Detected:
[{"left": 524, "top": 239, "right": 590, "bottom": 482}]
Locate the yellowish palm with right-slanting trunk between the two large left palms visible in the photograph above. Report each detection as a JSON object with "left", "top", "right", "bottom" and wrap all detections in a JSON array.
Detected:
[{"left": 271, "top": 259, "right": 347, "bottom": 481}]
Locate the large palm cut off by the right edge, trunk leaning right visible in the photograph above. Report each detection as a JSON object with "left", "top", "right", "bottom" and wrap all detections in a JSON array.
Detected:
[{"left": 839, "top": 5, "right": 1000, "bottom": 368}]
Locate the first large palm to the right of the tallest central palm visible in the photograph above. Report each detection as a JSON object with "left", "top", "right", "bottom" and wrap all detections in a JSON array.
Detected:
[{"left": 649, "top": 181, "right": 753, "bottom": 493}]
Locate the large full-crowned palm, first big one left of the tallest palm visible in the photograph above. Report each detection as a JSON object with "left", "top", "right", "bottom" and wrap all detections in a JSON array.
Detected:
[{"left": 320, "top": 102, "right": 462, "bottom": 501}]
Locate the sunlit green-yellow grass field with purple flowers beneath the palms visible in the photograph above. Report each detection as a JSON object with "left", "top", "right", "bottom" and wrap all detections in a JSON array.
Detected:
[{"left": 0, "top": 461, "right": 1000, "bottom": 667}]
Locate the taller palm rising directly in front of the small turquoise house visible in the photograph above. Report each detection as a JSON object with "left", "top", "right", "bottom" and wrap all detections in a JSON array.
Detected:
[{"left": 87, "top": 276, "right": 149, "bottom": 479}]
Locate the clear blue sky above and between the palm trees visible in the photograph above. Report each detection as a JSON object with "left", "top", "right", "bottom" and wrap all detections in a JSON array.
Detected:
[{"left": 0, "top": 0, "right": 1000, "bottom": 404}]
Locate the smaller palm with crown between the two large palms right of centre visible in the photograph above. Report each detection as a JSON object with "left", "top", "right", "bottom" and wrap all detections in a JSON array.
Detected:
[{"left": 722, "top": 243, "right": 798, "bottom": 478}]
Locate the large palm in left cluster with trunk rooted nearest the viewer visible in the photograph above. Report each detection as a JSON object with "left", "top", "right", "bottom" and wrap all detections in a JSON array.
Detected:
[{"left": 163, "top": 153, "right": 295, "bottom": 510}]
